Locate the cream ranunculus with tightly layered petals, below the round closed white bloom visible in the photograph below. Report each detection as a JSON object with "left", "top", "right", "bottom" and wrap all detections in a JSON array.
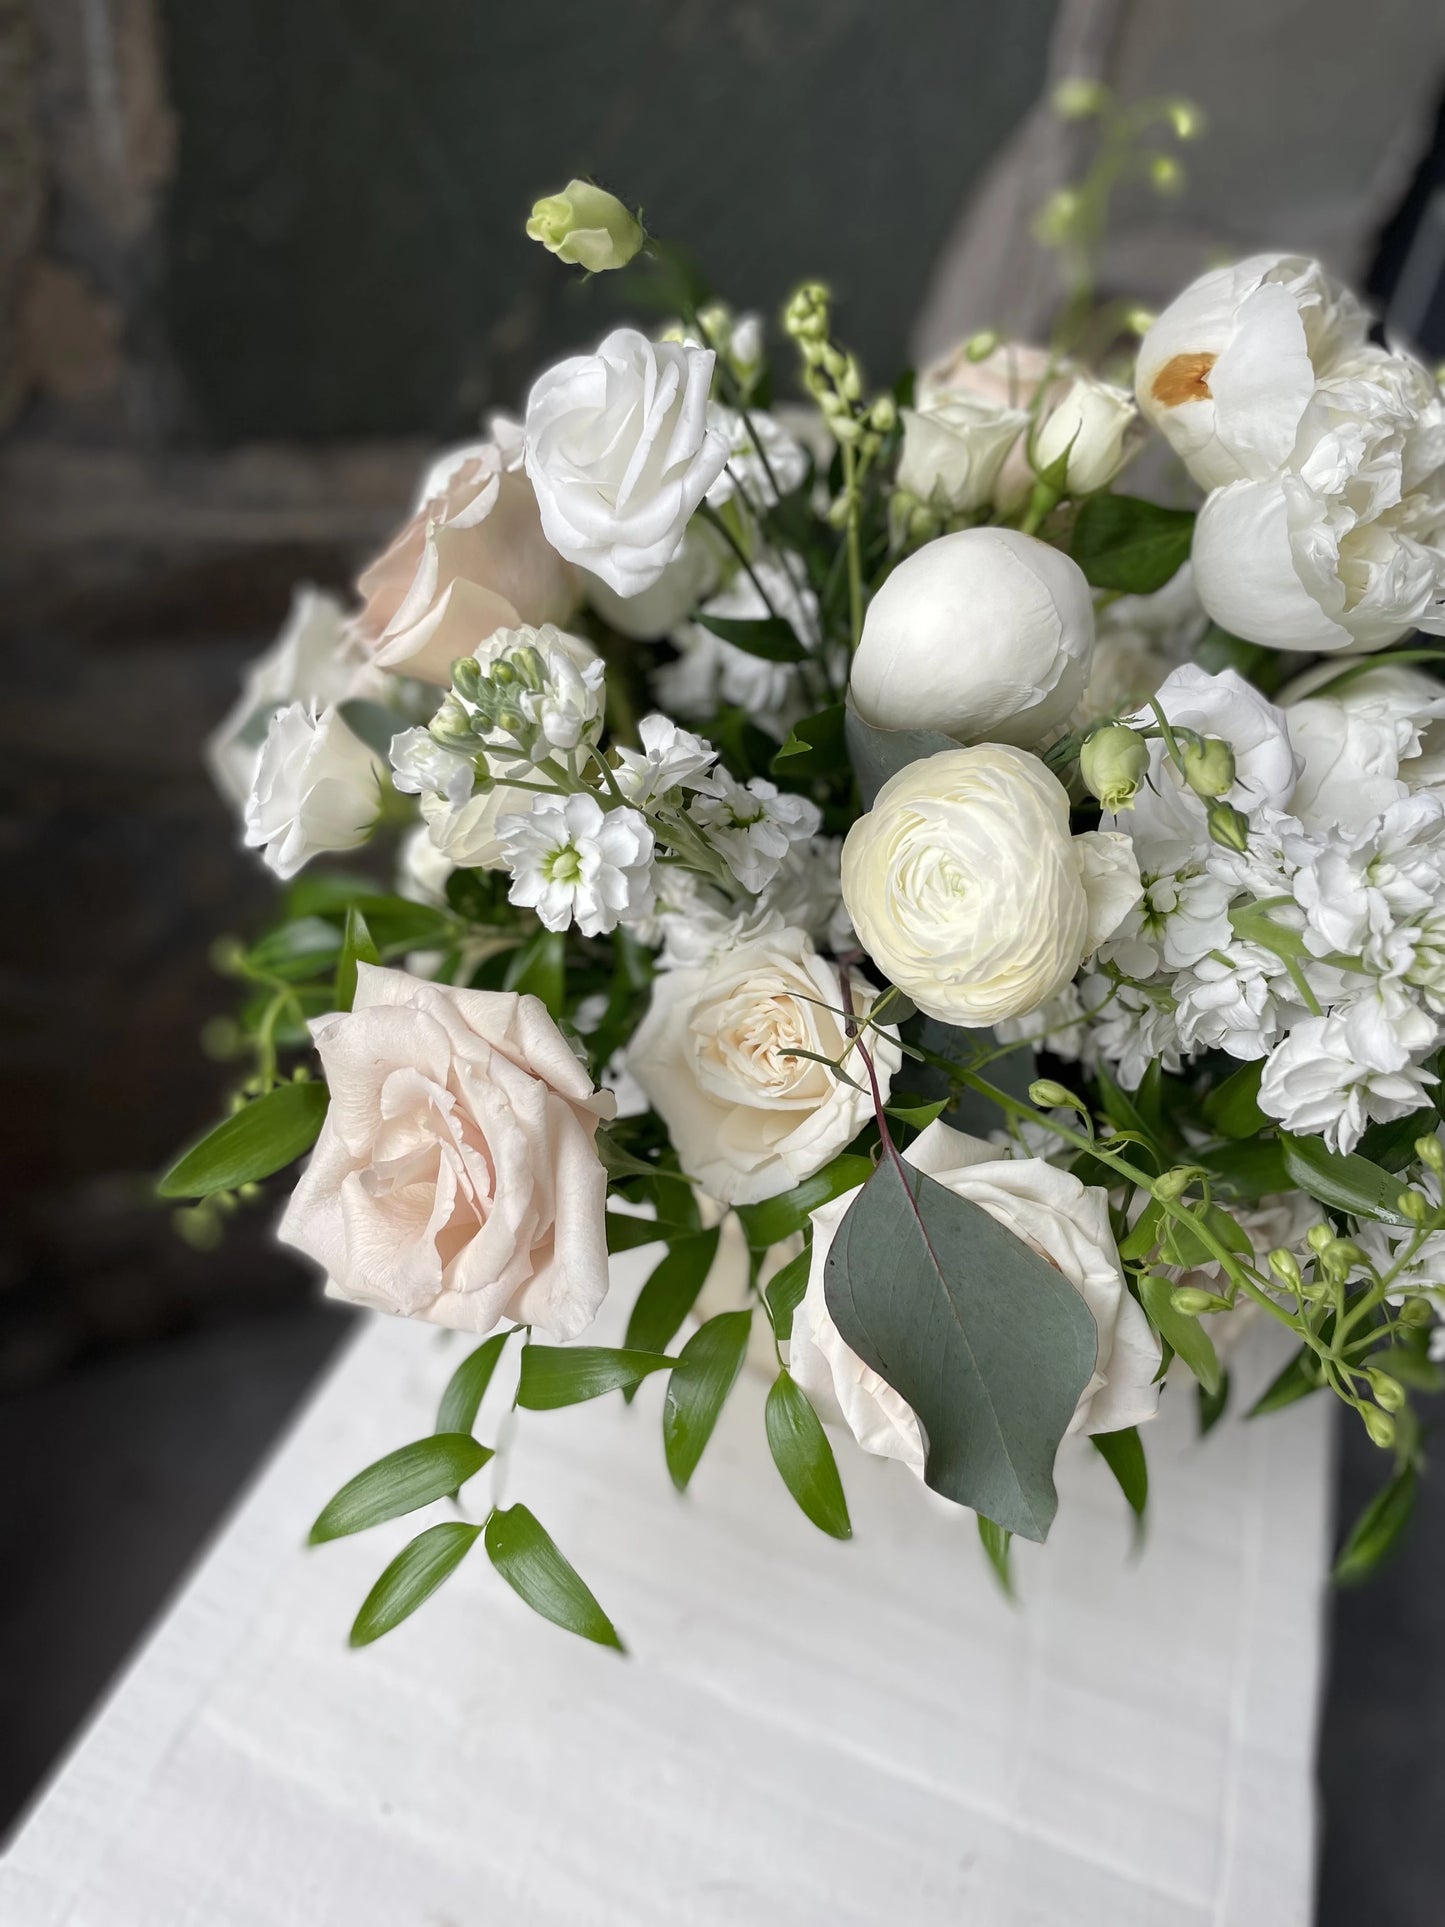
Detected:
[{"left": 842, "top": 744, "right": 1139, "bottom": 1025}]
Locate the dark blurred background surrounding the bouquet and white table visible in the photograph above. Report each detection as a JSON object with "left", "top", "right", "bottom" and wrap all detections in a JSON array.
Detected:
[{"left": 0, "top": 0, "right": 1445, "bottom": 1927}]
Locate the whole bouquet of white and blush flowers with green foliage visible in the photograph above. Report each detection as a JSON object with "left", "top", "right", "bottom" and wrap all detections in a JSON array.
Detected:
[{"left": 162, "top": 105, "right": 1445, "bottom": 1644}]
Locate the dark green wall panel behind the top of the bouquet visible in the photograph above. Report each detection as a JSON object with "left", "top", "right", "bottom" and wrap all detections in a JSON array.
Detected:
[{"left": 164, "top": 0, "right": 1054, "bottom": 441}]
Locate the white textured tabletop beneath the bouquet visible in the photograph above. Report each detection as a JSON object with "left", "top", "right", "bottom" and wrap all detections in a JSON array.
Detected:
[{"left": 0, "top": 1254, "right": 1329, "bottom": 1927}]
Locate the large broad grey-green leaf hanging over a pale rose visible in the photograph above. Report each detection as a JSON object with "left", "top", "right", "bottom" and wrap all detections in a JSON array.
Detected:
[{"left": 825, "top": 1158, "right": 1098, "bottom": 1540}]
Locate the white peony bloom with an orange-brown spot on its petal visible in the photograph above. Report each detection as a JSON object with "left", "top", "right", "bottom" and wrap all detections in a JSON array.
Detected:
[{"left": 1135, "top": 254, "right": 1368, "bottom": 493}]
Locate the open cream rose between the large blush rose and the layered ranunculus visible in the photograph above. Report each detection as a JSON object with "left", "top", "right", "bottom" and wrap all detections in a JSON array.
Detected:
[{"left": 626, "top": 929, "right": 902, "bottom": 1204}]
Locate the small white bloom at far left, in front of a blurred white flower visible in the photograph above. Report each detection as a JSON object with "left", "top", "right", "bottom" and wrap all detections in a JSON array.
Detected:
[{"left": 245, "top": 703, "right": 385, "bottom": 877}]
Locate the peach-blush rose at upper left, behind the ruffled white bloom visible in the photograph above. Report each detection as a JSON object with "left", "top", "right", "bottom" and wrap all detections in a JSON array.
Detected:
[{"left": 356, "top": 437, "right": 578, "bottom": 684}]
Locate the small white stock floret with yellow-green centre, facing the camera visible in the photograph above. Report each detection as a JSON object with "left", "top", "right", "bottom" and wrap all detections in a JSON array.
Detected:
[{"left": 501, "top": 790, "right": 653, "bottom": 937}]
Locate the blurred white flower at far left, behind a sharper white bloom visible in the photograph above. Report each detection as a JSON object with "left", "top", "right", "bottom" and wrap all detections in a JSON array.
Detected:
[{"left": 206, "top": 584, "right": 395, "bottom": 807}]
